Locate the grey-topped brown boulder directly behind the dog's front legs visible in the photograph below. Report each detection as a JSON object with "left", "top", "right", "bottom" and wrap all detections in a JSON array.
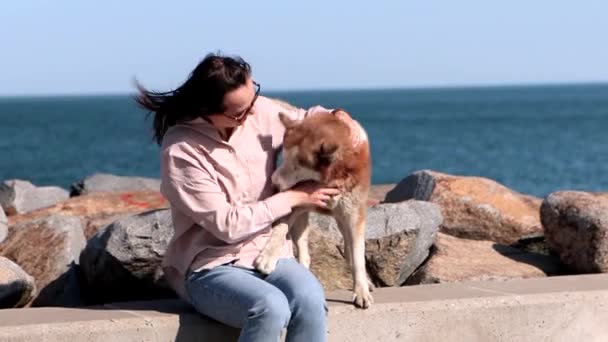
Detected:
[{"left": 309, "top": 201, "right": 442, "bottom": 290}]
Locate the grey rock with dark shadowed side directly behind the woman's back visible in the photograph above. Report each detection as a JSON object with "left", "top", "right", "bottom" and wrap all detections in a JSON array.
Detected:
[{"left": 80, "top": 209, "right": 175, "bottom": 304}]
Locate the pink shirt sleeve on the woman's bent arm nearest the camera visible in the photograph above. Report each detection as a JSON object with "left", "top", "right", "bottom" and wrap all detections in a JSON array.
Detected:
[{"left": 161, "top": 143, "right": 292, "bottom": 243}]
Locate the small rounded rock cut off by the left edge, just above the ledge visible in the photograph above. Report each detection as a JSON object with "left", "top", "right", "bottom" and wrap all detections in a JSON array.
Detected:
[{"left": 0, "top": 256, "right": 36, "bottom": 309}]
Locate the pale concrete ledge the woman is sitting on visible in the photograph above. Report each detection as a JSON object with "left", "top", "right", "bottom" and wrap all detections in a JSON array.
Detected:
[{"left": 0, "top": 274, "right": 608, "bottom": 342}]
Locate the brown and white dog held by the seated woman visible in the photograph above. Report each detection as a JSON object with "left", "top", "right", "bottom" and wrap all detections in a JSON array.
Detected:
[{"left": 255, "top": 109, "right": 373, "bottom": 308}]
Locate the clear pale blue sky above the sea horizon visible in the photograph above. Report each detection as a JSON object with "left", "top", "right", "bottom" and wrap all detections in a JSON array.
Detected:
[{"left": 0, "top": 0, "right": 608, "bottom": 95}]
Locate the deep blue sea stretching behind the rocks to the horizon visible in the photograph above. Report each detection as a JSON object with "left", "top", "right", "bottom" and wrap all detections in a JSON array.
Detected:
[{"left": 0, "top": 84, "right": 608, "bottom": 197}]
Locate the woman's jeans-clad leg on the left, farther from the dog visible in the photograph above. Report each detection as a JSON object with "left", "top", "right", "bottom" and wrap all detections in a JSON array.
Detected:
[{"left": 186, "top": 265, "right": 290, "bottom": 342}]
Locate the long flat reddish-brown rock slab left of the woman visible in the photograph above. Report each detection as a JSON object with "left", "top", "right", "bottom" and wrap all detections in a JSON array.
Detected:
[{"left": 8, "top": 191, "right": 168, "bottom": 239}]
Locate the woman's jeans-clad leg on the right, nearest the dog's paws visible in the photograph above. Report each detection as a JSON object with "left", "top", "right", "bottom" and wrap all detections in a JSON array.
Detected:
[{"left": 264, "top": 258, "right": 327, "bottom": 342}]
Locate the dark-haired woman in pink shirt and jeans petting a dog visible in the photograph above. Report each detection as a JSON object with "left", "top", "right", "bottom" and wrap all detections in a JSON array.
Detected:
[{"left": 137, "top": 54, "right": 338, "bottom": 341}]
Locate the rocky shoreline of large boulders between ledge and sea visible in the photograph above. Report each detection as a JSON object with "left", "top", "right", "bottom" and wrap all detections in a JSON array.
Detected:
[{"left": 0, "top": 170, "right": 608, "bottom": 308}]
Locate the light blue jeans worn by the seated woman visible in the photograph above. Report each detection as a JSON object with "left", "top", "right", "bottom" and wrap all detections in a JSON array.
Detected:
[{"left": 186, "top": 258, "right": 327, "bottom": 342}]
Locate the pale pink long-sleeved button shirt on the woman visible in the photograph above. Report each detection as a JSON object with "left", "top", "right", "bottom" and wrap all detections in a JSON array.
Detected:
[{"left": 161, "top": 96, "right": 326, "bottom": 298}]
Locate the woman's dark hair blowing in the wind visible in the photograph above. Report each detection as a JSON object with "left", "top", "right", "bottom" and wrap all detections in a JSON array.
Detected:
[{"left": 135, "top": 53, "right": 251, "bottom": 145}]
